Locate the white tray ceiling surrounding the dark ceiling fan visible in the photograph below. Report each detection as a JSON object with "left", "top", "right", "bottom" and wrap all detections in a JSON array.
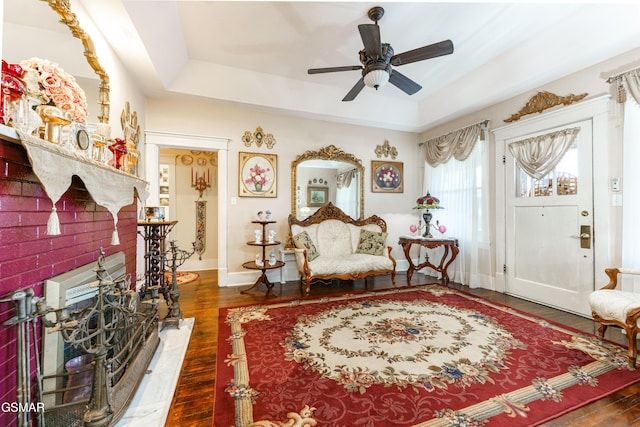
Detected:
[{"left": 4, "top": 0, "right": 640, "bottom": 132}]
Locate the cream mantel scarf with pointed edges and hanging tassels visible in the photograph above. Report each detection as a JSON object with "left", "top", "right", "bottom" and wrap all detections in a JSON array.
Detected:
[{"left": 16, "top": 129, "right": 149, "bottom": 245}]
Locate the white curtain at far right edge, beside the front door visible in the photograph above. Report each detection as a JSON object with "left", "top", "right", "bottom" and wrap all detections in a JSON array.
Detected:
[{"left": 615, "top": 70, "right": 640, "bottom": 293}]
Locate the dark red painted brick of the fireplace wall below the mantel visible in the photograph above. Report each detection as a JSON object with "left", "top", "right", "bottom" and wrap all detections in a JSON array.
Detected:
[{"left": 0, "top": 140, "right": 137, "bottom": 426}]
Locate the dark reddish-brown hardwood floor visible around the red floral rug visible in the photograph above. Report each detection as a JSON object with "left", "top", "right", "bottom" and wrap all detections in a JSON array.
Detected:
[{"left": 165, "top": 271, "right": 640, "bottom": 427}]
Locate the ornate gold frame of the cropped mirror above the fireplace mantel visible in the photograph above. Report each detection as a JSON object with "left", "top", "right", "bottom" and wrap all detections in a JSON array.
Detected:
[{"left": 41, "top": 0, "right": 110, "bottom": 123}]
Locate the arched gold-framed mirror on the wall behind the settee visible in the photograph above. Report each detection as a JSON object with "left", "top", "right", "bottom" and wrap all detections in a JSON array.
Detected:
[{"left": 291, "top": 145, "right": 364, "bottom": 219}]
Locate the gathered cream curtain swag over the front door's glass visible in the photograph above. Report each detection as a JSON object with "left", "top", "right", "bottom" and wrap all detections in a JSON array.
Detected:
[{"left": 509, "top": 128, "right": 580, "bottom": 179}]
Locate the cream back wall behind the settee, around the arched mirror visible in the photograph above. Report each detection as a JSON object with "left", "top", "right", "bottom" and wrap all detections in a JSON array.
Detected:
[{"left": 146, "top": 99, "right": 422, "bottom": 284}]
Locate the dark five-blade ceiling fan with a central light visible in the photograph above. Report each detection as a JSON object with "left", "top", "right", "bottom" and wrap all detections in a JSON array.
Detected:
[{"left": 307, "top": 6, "right": 453, "bottom": 101}]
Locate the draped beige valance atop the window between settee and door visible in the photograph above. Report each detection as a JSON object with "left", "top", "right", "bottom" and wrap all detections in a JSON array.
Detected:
[{"left": 424, "top": 121, "right": 487, "bottom": 167}]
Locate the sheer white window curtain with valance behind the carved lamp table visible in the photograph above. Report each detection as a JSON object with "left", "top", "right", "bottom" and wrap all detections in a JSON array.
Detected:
[{"left": 421, "top": 122, "right": 494, "bottom": 288}]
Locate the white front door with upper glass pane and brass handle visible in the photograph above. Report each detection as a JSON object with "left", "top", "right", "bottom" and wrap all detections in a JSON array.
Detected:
[{"left": 493, "top": 96, "right": 610, "bottom": 317}]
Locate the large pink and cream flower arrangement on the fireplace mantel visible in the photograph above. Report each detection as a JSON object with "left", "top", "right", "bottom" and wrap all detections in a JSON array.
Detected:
[{"left": 20, "top": 58, "right": 88, "bottom": 123}]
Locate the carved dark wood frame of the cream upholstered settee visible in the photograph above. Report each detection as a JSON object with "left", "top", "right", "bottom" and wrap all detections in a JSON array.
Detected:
[{"left": 289, "top": 202, "right": 396, "bottom": 295}]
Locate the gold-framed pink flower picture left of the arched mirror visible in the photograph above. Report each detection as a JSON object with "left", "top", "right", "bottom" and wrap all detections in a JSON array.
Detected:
[{"left": 238, "top": 151, "right": 278, "bottom": 197}]
